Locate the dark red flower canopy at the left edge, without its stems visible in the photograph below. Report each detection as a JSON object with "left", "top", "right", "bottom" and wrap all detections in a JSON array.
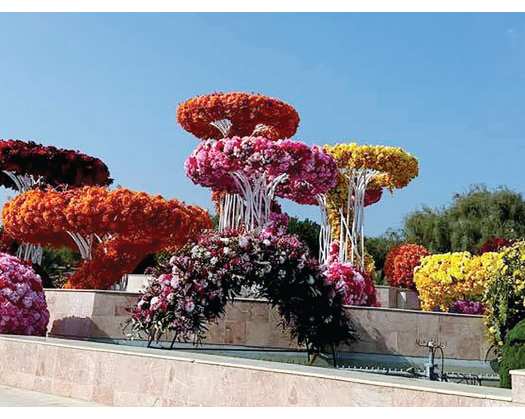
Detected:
[{"left": 0, "top": 140, "right": 112, "bottom": 188}]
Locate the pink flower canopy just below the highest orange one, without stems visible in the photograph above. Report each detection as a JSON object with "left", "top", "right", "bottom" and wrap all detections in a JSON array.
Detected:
[{"left": 185, "top": 137, "right": 337, "bottom": 205}]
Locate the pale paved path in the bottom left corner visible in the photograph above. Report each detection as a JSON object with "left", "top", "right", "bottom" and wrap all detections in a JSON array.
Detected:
[{"left": 0, "top": 385, "right": 100, "bottom": 407}]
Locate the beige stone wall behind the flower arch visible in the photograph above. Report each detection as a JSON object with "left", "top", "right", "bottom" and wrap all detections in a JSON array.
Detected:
[{"left": 46, "top": 289, "right": 489, "bottom": 360}]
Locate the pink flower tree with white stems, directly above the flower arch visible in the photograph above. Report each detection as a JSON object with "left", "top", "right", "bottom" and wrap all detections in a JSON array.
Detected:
[{"left": 185, "top": 137, "right": 337, "bottom": 230}]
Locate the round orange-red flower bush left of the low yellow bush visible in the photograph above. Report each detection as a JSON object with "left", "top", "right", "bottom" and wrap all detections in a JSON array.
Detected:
[{"left": 383, "top": 244, "right": 430, "bottom": 289}]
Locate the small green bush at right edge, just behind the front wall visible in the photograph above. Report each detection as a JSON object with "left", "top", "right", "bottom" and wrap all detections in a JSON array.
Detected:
[{"left": 499, "top": 320, "right": 525, "bottom": 388}]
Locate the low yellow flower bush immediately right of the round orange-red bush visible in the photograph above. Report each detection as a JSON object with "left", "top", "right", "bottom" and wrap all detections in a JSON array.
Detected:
[{"left": 414, "top": 252, "right": 501, "bottom": 311}]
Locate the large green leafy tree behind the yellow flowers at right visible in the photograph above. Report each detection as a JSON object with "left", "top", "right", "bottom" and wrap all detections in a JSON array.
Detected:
[{"left": 403, "top": 185, "right": 525, "bottom": 253}]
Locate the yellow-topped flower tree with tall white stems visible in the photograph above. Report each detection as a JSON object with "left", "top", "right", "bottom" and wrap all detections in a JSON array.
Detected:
[{"left": 324, "top": 143, "right": 419, "bottom": 270}]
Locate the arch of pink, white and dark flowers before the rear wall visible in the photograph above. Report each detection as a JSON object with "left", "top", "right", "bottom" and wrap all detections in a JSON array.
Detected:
[{"left": 126, "top": 230, "right": 353, "bottom": 351}]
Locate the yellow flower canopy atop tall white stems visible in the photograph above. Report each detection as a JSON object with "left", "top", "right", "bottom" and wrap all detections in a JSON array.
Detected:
[{"left": 324, "top": 143, "right": 419, "bottom": 190}]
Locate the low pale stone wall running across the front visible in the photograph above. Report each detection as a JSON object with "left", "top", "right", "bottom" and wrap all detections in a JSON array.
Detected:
[{"left": 0, "top": 336, "right": 516, "bottom": 406}]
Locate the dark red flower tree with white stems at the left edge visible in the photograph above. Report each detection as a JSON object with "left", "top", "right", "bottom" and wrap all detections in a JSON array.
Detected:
[{"left": 0, "top": 140, "right": 112, "bottom": 264}]
